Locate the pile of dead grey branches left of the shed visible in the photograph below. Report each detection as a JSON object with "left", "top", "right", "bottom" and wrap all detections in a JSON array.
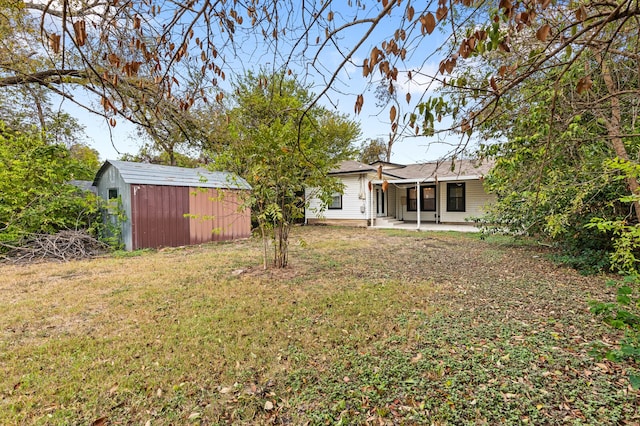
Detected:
[{"left": 0, "top": 231, "right": 109, "bottom": 263}]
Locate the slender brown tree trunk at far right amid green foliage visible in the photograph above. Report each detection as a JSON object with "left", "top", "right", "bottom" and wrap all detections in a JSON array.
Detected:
[{"left": 596, "top": 52, "right": 640, "bottom": 223}]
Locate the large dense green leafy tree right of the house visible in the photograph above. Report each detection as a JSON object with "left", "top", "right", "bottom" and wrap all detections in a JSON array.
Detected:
[{"left": 430, "top": 1, "right": 639, "bottom": 268}]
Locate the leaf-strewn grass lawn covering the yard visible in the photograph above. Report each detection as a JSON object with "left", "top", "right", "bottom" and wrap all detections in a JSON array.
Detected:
[{"left": 0, "top": 227, "right": 640, "bottom": 425}]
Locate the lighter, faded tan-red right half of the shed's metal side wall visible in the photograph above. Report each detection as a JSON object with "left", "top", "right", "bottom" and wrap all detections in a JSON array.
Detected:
[{"left": 189, "top": 188, "right": 251, "bottom": 244}]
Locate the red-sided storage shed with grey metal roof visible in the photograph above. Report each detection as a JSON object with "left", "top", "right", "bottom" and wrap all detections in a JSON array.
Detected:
[{"left": 93, "top": 160, "right": 251, "bottom": 250}]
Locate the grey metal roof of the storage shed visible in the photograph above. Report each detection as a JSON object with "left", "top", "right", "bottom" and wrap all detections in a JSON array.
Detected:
[{"left": 93, "top": 160, "right": 251, "bottom": 189}]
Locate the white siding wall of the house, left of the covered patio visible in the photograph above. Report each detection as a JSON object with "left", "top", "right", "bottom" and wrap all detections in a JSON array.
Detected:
[{"left": 305, "top": 175, "right": 368, "bottom": 220}]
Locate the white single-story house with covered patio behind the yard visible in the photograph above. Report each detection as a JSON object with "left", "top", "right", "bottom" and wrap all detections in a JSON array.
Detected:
[{"left": 305, "top": 160, "right": 495, "bottom": 228}]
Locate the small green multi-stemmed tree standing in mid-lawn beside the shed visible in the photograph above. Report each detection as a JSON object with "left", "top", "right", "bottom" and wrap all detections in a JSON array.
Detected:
[{"left": 211, "top": 71, "right": 359, "bottom": 268}]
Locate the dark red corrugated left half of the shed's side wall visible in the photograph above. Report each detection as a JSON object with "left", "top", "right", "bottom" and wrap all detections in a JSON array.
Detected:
[{"left": 131, "top": 185, "right": 189, "bottom": 250}]
